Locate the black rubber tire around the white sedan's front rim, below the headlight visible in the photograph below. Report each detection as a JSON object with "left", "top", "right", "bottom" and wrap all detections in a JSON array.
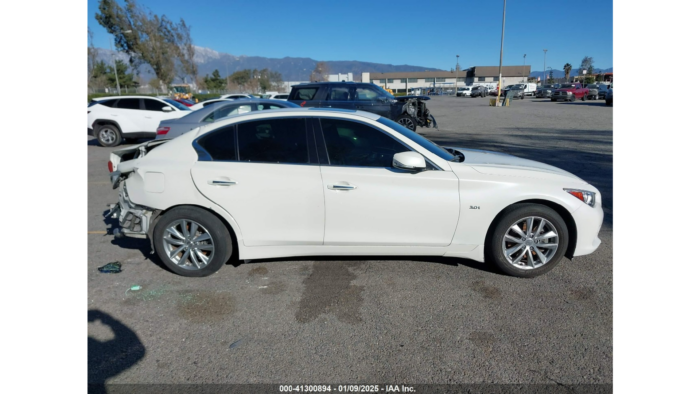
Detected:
[{"left": 486, "top": 204, "right": 569, "bottom": 279}]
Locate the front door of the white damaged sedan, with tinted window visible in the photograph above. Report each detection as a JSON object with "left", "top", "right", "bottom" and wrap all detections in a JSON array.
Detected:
[{"left": 314, "top": 118, "right": 460, "bottom": 247}]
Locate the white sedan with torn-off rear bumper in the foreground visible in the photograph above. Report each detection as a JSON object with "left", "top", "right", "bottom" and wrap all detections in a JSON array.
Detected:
[{"left": 109, "top": 109, "right": 604, "bottom": 278}]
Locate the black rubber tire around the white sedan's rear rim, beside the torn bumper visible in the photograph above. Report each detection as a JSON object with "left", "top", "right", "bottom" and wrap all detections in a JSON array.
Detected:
[{"left": 153, "top": 207, "right": 234, "bottom": 278}]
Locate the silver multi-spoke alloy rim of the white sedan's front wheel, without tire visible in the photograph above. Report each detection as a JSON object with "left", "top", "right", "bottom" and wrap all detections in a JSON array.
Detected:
[{"left": 503, "top": 217, "right": 559, "bottom": 271}]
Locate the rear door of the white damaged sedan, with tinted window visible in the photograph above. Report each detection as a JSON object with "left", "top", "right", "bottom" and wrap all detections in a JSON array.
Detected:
[{"left": 192, "top": 118, "right": 325, "bottom": 247}]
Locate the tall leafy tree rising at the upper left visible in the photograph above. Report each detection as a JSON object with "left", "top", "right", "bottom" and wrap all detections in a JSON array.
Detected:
[{"left": 95, "top": 0, "right": 179, "bottom": 85}]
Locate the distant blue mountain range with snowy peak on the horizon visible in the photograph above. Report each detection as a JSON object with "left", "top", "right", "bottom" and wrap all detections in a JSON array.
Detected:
[{"left": 98, "top": 47, "right": 443, "bottom": 82}]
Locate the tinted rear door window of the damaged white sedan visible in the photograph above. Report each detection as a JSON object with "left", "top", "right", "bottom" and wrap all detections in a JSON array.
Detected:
[{"left": 238, "top": 119, "right": 311, "bottom": 164}]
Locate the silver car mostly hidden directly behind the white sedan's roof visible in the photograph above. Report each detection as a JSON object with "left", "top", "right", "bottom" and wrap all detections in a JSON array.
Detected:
[{"left": 156, "top": 100, "right": 300, "bottom": 140}]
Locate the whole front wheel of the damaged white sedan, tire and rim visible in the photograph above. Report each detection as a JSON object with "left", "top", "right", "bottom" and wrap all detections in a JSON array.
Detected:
[{"left": 487, "top": 204, "right": 569, "bottom": 278}]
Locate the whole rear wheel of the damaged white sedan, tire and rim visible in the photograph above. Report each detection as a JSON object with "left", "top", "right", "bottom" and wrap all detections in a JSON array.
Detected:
[{"left": 153, "top": 207, "right": 233, "bottom": 278}]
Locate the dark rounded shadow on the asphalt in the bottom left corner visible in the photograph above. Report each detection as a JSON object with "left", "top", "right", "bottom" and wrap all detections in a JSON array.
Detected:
[{"left": 87, "top": 310, "right": 146, "bottom": 394}]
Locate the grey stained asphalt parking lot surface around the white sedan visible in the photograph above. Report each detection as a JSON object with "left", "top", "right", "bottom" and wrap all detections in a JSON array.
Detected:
[{"left": 87, "top": 97, "right": 615, "bottom": 385}]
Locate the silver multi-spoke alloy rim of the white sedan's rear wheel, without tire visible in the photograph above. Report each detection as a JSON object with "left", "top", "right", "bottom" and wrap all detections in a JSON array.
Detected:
[{"left": 163, "top": 220, "right": 216, "bottom": 271}]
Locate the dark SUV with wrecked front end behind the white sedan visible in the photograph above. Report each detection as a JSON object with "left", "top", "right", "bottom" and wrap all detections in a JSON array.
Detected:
[{"left": 289, "top": 82, "right": 437, "bottom": 131}]
